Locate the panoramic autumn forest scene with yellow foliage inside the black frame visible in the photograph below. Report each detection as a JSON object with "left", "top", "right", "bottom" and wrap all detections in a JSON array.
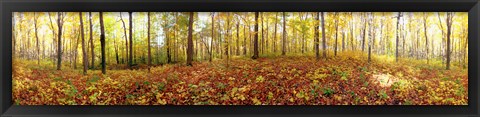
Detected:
[{"left": 12, "top": 12, "right": 468, "bottom": 105}]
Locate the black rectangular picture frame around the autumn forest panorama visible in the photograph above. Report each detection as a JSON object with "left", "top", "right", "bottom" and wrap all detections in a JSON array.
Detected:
[{"left": 0, "top": 0, "right": 480, "bottom": 117}]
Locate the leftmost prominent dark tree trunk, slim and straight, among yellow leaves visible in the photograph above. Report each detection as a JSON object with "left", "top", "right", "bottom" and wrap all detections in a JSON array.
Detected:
[{"left": 57, "top": 12, "right": 63, "bottom": 70}]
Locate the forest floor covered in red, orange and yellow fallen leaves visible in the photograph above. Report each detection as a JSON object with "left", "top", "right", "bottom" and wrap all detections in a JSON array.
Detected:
[{"left": 12, "top": 53, "right": 468, "bottom": 105}]
